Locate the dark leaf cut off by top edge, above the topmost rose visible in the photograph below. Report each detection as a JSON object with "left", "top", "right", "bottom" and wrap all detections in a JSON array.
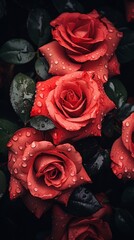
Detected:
[{"left": 52, "top": 0, "right": 84, "bottom": 13}]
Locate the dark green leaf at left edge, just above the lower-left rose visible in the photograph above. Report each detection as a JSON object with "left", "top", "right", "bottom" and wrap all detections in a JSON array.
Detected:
[{"left": 0, "top": 119, "right": 19, "bottom": 153}]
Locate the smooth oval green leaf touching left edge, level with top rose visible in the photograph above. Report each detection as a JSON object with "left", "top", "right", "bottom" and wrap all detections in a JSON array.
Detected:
[{"left": 0, "top": 38, "right": 35, "bottom": 64}]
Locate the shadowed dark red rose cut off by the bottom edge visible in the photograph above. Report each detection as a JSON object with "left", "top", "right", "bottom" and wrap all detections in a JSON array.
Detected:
[{"left": 47, "top": 193, "right": 112, "bottom": 240}]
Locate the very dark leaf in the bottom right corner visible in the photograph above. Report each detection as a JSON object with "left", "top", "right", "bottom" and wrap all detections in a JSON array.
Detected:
[{"left": 114, "top": 209, "right": 134, "bottom": 238}]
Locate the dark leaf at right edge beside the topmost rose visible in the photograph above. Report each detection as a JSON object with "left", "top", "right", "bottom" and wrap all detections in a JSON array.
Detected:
[{"left": 116, "top": 28, "right": 134, "bottom": 63}]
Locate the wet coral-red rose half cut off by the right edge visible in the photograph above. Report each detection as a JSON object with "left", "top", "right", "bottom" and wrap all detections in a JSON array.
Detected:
[{"left": 110, "top": 113, "right": 134, "bottom": 180}]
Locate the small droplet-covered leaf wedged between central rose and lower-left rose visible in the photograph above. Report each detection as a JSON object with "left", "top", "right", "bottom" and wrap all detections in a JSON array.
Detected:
[{"left": 30, "top": 116, "right": 55, "bottom": 131}]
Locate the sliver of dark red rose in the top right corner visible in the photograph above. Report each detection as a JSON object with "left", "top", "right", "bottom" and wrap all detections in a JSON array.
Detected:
[{"left": 124, "top": 0, "right": 134, "bottom": 22}]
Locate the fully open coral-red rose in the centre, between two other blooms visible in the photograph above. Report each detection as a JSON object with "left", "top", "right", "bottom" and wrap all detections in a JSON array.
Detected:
[{"left": 31, "top": 71, "right": 115, "bottom": 144}]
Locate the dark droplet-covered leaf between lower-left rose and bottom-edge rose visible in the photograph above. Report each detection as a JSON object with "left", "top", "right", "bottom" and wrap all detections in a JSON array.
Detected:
[{"left": 67, "top": 184, "right": 102, "bottom": 216}]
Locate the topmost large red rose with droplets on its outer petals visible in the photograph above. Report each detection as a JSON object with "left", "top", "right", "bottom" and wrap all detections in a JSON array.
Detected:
[{"left": 39, "top": 10, "right": 122, "bottom": 82}]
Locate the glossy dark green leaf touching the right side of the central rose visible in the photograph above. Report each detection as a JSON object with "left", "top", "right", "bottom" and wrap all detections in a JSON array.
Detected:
[{"left": 104, "top": 77, "right": 127, "bottom": 108}]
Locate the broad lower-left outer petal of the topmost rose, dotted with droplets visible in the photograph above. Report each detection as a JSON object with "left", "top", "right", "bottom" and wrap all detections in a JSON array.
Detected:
[{"left": 39, "top": 41, "right": 81, "bottom": 75}]
